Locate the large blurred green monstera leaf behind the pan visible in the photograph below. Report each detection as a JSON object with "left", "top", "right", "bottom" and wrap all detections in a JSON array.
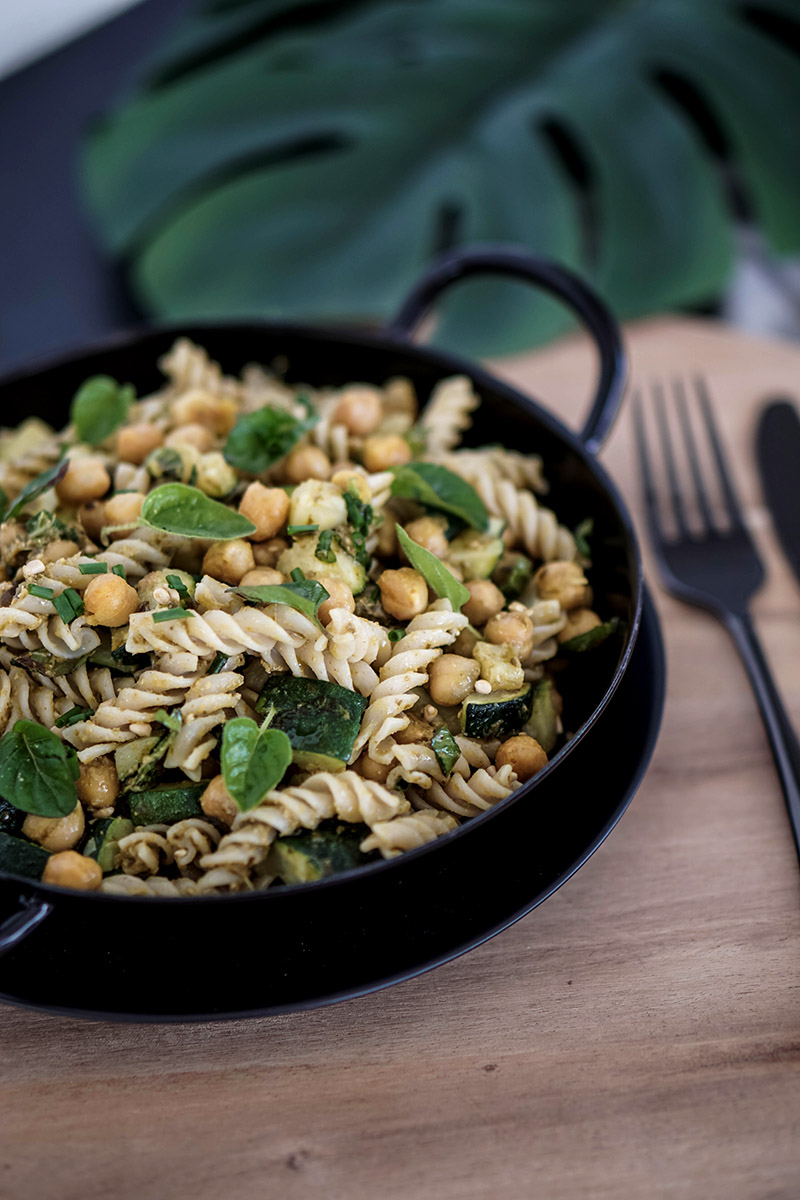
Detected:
[{"left": 84, "top": 0, "right": 800, "bottom": 353}]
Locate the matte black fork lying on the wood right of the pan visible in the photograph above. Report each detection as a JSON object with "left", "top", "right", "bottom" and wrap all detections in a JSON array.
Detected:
[{"left": 633, "top": 378, "right": 800, "bottom": 858}]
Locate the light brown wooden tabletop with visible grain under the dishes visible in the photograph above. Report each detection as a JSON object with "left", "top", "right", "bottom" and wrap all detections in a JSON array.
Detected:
[{"left": 0, "top": 318, "right": 800, "bottom": 1200}]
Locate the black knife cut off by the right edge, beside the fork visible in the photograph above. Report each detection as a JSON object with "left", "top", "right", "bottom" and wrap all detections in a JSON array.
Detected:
[{"left": 756, "top": 400, "right": 800, "bottom": 580}]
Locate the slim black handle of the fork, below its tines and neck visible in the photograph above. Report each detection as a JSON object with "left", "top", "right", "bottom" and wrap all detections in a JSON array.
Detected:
[{"left": 724, "top": 613, "right": 800, "bottom": 859}]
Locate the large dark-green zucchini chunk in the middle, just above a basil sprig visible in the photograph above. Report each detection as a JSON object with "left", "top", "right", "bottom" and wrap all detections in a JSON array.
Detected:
[{"left": 255, "top": 676, "right": 367, "bottom": 770}]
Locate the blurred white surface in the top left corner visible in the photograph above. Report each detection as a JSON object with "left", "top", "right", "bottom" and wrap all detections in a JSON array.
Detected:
[{"left": 0, "top": 0, "right": 139, "bottom": 76}]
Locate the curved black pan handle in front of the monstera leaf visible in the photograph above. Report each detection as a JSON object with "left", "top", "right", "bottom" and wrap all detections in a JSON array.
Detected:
[{"left": 386, "top": 244, "right": 626, "bottom": 454}]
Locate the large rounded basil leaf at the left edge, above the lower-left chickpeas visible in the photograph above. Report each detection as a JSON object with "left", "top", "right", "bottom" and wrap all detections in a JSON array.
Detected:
[{"left": 0, "top": 720, "right": 78, "bottom": 817}]
